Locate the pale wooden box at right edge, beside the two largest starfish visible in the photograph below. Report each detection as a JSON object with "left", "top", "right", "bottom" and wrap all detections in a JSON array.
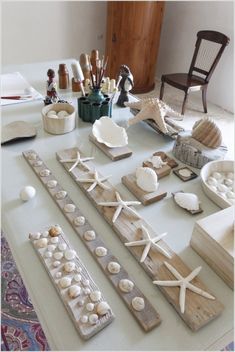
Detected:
[{"left": 190, "top": 207, "right": 235, "bottom": 289}]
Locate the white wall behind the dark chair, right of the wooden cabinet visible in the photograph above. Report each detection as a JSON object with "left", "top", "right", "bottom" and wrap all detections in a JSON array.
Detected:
[{"left": 157, "top": 1, "right": 234, "bottom": 111}]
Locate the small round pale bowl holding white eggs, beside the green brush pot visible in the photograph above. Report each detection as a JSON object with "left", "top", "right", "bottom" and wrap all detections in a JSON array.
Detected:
[{"left": 42, "top": 103, "right": 76, "bottom": 134}]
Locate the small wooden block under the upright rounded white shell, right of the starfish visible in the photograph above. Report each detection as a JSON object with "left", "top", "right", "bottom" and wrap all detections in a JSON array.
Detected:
[{"left": 122, "top": 174, "right": 167, "bottom": 205}]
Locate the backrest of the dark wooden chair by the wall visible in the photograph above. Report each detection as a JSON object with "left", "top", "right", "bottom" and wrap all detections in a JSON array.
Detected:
[{"left": 189, "top": 31, "right": 230, "bottom": 82}]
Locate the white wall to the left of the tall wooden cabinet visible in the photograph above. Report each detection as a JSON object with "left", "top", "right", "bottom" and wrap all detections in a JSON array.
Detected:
[{"left": 2, "top": 1, "right": 106, "bottom": 65}]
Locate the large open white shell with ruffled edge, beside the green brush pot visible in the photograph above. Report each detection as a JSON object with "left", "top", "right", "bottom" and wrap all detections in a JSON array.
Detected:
[{"left": 92, "top": 116, "right": 128, "bottom": 148}]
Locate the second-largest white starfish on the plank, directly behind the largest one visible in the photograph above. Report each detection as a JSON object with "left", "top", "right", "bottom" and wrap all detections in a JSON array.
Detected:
[{"left": 125, "top": 225, "right": 171, "bottom": 263}]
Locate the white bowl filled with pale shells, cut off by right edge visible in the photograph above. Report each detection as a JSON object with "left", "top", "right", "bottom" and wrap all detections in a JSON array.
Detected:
[{"left": 201, "top": 160, "right": 235, "bottom": 209}]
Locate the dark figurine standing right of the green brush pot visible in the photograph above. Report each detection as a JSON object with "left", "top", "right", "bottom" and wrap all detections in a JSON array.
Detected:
[{"left": 117, "top": 65, "right": 134, "bottom": 107}]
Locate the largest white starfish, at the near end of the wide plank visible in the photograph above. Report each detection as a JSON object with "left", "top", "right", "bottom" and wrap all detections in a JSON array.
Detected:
[{"left": 153, "top": 262, "right": 215, "bottom": 314}]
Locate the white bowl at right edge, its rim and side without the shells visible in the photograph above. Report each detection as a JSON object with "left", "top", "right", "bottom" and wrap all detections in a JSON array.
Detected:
[{"left": 200, "top": 160, "right": 234, "bottom": 209}]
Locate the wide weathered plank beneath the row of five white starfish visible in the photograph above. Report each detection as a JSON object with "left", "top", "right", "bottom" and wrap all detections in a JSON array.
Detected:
[{"left": 57, "top": 148, "right": 224, "bottom": 331}]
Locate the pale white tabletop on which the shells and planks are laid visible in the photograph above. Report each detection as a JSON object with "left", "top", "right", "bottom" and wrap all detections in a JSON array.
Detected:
[{"left": 2, "top": 60, "right": 233, "bottom": 351}]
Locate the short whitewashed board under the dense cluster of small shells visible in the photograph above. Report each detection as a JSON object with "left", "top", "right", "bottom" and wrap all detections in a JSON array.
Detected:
[{"left": 30, "top": 228, "right": 114, "bottom": 340}]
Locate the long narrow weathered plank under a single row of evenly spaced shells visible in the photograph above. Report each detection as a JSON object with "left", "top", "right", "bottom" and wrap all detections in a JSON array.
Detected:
[{"left": 23, "top": 150, "right": 161, "bottom": 332}]
